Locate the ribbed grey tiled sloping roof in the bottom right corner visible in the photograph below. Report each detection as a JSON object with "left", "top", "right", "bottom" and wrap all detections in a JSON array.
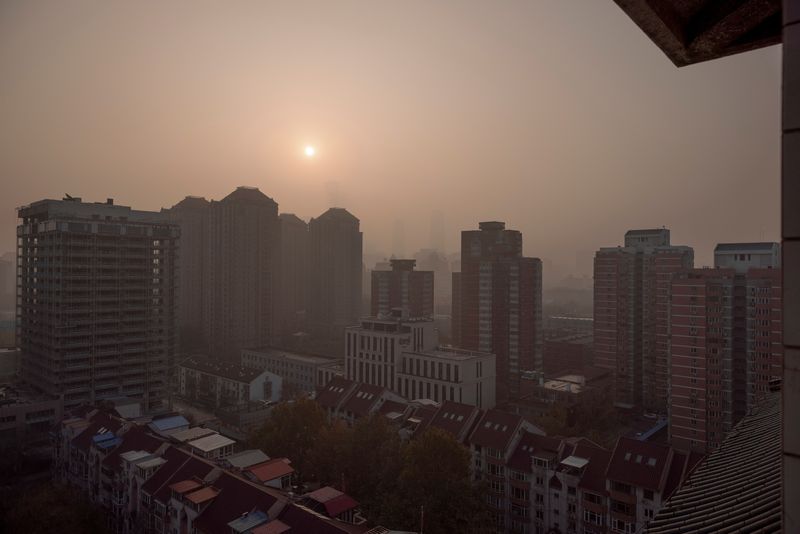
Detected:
[{"left": 647, "top": 393, "right": 783, "bottom": 534}]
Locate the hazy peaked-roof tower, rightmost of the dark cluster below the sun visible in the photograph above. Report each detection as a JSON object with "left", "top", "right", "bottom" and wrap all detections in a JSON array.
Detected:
[{"left": 308, "top": 208, "right": 363, "bottom": 353}]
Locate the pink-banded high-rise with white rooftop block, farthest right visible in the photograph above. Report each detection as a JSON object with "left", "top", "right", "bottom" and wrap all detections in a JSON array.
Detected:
[{"left": 670, "top": 243, "right": 783, "bottom": 451}]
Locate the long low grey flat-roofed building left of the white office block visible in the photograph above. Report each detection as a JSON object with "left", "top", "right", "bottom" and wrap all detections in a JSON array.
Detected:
[{"left": 241, "top": 347, "right": 341, "bottom": 395}]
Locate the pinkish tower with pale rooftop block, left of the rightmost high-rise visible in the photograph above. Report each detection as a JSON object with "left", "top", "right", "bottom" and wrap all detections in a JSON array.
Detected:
[{"left": 594, "top": 228, "right": 694, "bottom": 413}]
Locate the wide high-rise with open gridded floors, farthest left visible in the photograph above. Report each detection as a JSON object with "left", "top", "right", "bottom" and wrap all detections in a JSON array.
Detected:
[{"left": 17, "top": 196, "right": 179, "bottom": 412}]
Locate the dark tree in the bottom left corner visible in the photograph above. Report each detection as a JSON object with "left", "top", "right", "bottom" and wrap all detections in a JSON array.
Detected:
[{"left": 0, "top": 484, "right": 109, "bottom": 534}]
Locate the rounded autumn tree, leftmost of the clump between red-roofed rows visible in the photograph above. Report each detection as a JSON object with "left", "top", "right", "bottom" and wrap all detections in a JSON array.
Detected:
[{"left": 251, "top": 398, "right": 327, "bottom": 476}]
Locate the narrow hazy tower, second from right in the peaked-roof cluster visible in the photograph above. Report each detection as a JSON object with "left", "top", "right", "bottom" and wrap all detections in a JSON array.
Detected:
[{"left": 278, "top": 213, "right": 309, "bottom": 336}]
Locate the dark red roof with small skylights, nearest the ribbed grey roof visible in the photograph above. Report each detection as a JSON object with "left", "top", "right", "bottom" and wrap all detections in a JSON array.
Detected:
[{"left": 606, "top": 437, "right": 672, "bottom": 491}]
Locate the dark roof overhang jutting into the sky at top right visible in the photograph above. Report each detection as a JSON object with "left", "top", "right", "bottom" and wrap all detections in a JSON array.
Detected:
[{"left": 614, "top": 0, "right": 782, "bottom": 67}]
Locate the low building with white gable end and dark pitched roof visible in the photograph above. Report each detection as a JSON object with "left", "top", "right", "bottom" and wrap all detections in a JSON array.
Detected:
[{"left": 178, "top": 358, "right": 282, "bottom": 408}]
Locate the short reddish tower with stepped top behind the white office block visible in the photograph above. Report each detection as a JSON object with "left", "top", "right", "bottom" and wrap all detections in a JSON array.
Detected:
[{"left": 371, "top": 259, "right": 433, "bottom": 317}]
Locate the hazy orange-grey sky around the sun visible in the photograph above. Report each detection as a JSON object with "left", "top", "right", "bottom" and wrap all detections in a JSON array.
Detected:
[{"left": 0, "top": 0, "right": 780, "bottom": 281}]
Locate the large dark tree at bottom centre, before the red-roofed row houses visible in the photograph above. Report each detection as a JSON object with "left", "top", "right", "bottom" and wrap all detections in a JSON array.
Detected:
[{"left": 378, "top": 428, "right": 491, "bottom": 534}]
